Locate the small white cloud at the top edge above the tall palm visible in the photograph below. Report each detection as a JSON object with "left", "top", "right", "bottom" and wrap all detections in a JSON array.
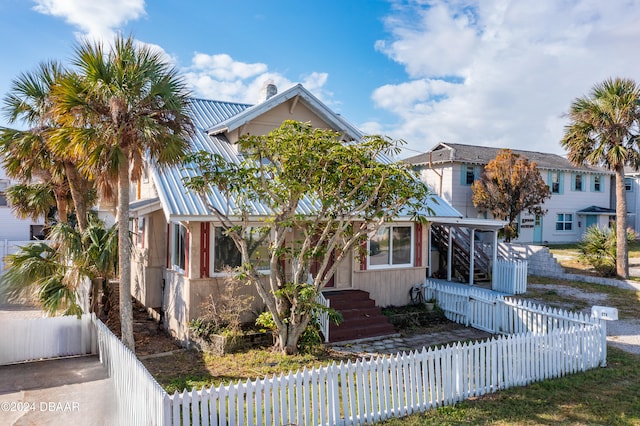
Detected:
[{"left": 33, "top": 0, "right": 145, "bottom": 40}]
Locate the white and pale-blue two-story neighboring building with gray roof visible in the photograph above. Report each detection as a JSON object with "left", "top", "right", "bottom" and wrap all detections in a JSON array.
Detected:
[{"left": 405, "top": 143, "right": 615, "bottom": 243}]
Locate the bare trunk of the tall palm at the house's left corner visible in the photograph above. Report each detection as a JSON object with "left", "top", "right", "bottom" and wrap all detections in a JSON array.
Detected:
[{"left": 117, "top": 148, "right": 135, "bottom": 352}]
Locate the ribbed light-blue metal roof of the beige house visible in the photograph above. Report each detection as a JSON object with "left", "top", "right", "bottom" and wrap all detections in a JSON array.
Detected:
[{"left": 151, "top": 92, "right": 462, "bottom": 221}]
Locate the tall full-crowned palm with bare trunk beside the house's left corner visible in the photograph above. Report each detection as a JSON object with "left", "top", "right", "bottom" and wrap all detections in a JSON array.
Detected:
[{"left": 54, "top": 36, "right": 192, "bottom": 350}]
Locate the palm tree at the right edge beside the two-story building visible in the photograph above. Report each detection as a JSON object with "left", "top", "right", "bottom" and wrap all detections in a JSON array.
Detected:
[{"left": 560, "top": 78, "right": 640, "bottom": 278}]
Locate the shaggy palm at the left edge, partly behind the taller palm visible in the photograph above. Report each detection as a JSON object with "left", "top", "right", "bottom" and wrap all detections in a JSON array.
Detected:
[{"left": 0, "top": 62, "right": 92, "bottom": 230}]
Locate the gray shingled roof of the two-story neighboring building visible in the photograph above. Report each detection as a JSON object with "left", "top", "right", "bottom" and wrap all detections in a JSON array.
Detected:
[{"left": 405, "top": 142, "right": 613, "bottom": 174}]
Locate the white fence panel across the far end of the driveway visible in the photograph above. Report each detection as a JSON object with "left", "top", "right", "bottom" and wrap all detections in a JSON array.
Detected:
[{"left": 0, "top": 315, "right": 97, "bottom": 365}]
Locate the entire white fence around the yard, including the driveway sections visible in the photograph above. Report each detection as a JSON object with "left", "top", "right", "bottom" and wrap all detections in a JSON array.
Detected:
[{"left": 0, "top": 281, "right": 606, "bottom": 425}]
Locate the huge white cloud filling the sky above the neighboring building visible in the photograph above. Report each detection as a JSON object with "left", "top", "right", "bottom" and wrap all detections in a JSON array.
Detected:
[{"left": 372, "top": 0, "right": 640, "bottom": 155}]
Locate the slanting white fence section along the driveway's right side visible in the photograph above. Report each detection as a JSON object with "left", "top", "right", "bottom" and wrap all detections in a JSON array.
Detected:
[{"left": 92, "top": 315, "right": 168, "bottom": 425}]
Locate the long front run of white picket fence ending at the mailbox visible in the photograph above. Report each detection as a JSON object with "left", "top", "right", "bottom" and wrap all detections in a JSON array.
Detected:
[{"left": 166, "top": 327, "right": 600, "bottom": 425}]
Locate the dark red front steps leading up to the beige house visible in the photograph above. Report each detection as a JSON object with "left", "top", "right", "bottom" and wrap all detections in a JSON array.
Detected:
[{"left": 324, "top": 290, "right": 397, "bottom": 343}]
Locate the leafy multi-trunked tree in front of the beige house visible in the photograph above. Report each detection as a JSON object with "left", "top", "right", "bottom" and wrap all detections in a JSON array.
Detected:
[{"left": 185, "top": 121, "right": 430, "bottom": 354}]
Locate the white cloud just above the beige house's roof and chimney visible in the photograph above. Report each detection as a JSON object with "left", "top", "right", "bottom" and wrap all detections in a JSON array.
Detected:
[{"left": 183, "top": 52, "right": 331, "bottom": 104}]
